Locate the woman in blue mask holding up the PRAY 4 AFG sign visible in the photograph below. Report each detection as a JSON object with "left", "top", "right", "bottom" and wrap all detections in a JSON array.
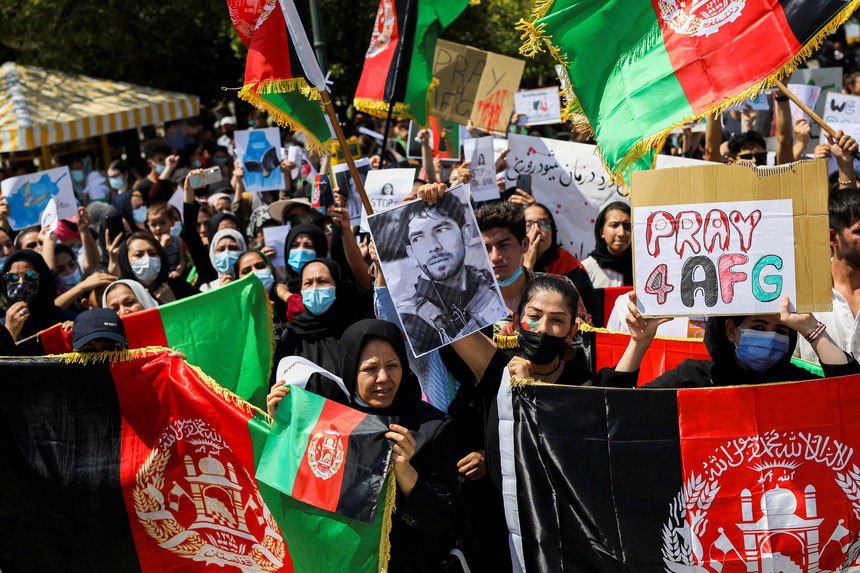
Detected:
[{"left": 617, "top": 293, "right": 860, "bottom": 388}]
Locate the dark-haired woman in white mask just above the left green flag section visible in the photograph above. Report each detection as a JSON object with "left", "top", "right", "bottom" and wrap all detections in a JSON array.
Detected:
[{"left": 118, "top": 231, "right": 199, "bottom": 304}]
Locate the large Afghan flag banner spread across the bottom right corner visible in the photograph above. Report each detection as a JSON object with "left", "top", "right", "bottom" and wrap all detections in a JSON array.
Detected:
[{"left": 498, "top": 376, "right": 860, "bottom": 573}]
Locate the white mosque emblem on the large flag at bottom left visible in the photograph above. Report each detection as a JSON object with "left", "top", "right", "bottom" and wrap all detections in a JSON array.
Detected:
[{"left": 131, "top": 419, "right": 286, "bottom": 573}]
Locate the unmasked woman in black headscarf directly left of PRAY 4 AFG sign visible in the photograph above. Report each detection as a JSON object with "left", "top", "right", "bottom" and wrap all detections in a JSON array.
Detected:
[{"left": 582, "top": 201, "right": 633, "bottom": 288}]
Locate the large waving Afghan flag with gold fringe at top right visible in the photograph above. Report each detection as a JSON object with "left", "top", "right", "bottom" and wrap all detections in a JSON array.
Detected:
[{"left": 518, "top": 0, "right": 858, "bottom": 182}]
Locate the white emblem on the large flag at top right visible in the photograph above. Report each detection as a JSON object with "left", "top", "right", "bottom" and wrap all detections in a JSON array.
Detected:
[{"left": 658, "top": 0, "right": 747, "bottom": 37}]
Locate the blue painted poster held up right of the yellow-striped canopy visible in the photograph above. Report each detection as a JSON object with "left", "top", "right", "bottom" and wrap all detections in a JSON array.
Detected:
[{"left": 235, "top": 127, "right": 285, "bottom": 193}]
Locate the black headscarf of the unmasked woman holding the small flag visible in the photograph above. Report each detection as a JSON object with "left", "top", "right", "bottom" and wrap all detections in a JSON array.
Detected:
[{"left": 340, "top": 319, "right": 421, "bottom": 417}]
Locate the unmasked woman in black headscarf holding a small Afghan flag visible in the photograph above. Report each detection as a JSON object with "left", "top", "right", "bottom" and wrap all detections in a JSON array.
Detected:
[{"left": 267, "top": 320, "right": 457, "bottom": 573}]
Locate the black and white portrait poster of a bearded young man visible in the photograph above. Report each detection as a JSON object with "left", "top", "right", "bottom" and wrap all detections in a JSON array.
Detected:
[{"left": 368, "top": 185, "right": 508, "bottom": 356}]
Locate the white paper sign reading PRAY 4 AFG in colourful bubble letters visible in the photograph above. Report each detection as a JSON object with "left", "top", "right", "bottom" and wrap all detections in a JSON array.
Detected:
[{"left": 633, "top": 199, "right": 797, "bottom": 316}]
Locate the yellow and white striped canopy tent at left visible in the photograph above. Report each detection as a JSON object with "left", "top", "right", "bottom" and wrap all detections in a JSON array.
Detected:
[{"left": 0, "top": 62, "right": 200, "bottom": 163}]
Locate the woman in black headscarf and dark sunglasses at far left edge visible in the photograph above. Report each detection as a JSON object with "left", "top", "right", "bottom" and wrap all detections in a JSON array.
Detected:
[{"left": 0, "top": 249, "right": 75, "bottom": 340}]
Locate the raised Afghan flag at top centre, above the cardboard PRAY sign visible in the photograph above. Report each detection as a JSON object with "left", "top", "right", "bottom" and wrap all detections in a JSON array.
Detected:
[{"left": 354, "top": 0, "right": 470, "bottom": 127}]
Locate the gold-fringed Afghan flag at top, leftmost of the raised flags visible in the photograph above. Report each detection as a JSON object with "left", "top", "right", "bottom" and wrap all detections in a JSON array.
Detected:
[{"left": 227, "top": 0, "right": 336, "bottom": 153}]
